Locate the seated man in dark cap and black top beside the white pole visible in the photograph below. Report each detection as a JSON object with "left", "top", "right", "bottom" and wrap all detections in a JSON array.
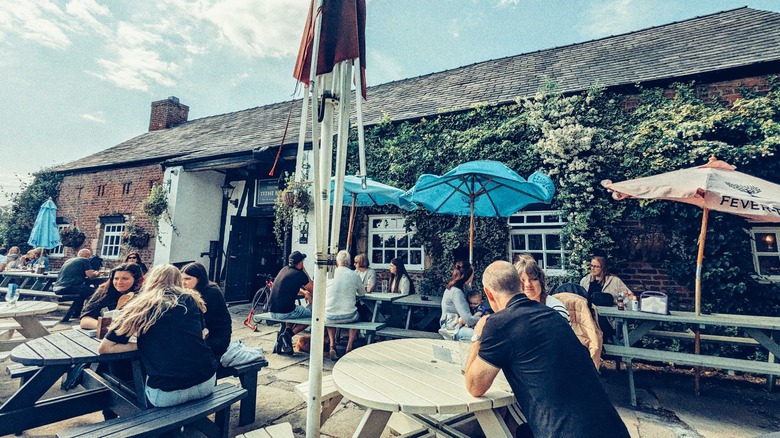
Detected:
[{"left": 269, "top": 251, "right": 314, "bottom": 354}]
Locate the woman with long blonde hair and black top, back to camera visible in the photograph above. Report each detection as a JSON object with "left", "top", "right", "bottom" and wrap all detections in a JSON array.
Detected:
[{"left": 98, "top": 264, "right": 217, "bottom": 407}]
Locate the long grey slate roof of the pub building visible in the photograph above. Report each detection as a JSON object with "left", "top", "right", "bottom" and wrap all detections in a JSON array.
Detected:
[{"left": 56, "top": 8, "right": 780, "bottom": 171}]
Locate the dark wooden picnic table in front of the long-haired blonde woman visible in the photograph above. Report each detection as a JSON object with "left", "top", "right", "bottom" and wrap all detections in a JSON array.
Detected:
[{"left": 0, "top": 329, "right": 146, "bottom": 435}]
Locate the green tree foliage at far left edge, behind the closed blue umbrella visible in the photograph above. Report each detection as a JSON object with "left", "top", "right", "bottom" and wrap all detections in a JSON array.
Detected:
[{"left": 0, "top": 169, "right": 62, "bottom": 253}]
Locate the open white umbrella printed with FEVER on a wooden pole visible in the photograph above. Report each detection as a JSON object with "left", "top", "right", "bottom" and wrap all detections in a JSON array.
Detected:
[{"left": 601, "top": 156, "right": 780, "bottom": 394}]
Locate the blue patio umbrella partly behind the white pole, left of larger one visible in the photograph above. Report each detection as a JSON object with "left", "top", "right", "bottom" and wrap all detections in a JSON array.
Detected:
[{"left": 330, "top": 176, "right": 417, "bottom": 248}]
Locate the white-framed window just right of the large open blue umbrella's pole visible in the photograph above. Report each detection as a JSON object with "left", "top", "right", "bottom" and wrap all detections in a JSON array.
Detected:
[{"left": 507, "top": 210, "right": 571, "bottom": 275}]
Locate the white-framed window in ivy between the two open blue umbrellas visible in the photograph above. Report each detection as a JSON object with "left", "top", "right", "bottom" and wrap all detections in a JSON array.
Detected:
[{"left": 368, "top": 215, "right": 425, "bottom": 270}]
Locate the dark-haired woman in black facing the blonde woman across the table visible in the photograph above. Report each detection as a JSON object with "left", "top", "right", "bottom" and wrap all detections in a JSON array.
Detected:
[{"left": 79, "top": 263, "right": 143, "bottom": 330}]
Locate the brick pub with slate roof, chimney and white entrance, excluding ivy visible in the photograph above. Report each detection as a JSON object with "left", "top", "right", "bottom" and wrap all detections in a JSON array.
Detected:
[{"left": 53, "top": 8, "right": 780, "bottom": 299}]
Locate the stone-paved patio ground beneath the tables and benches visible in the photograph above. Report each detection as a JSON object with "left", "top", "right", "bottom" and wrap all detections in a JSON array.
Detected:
[{"left": 0, "top": 304, "right": 780, "bottom": 438}]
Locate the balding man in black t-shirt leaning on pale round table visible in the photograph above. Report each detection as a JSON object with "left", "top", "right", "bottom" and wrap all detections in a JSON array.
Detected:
[{"left": 466, "top": 261, "right": 629, "bottom": 438}]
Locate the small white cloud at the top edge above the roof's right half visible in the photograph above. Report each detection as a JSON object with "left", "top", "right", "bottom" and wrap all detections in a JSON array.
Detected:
[{"left": 579, "top": 0, "right": 653, "bottom": 39}]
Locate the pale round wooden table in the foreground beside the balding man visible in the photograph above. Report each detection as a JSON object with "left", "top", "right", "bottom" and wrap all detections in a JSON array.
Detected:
[{"left": 333, "top": 339, "right": 515, "bottom": 437}]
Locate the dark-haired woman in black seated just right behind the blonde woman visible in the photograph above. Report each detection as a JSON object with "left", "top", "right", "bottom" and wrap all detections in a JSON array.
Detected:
[{"left": 181, "top": 263, "right": 233, "bottom": 360}]
